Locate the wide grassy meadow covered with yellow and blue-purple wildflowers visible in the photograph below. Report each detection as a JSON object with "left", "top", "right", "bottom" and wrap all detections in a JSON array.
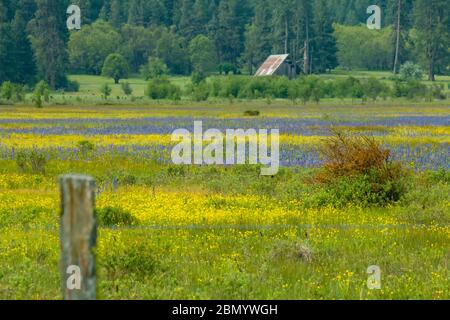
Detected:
[{"left": 0, "top": 72, "right": 450, "bottom": 299}]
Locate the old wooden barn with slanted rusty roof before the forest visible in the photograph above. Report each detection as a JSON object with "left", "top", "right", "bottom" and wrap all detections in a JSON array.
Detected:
[{"left": 255, "top": 54, "right": 297, "bottom": 79}]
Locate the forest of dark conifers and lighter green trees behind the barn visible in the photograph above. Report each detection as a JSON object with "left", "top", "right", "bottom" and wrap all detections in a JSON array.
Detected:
[{"left": 0, "top": 0, "right": 450, "bottom": 89}]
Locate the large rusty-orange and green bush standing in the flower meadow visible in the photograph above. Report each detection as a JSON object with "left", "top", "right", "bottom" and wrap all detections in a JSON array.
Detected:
[{"left": 315, "top": 130, "right": 407, "bottom": 206}]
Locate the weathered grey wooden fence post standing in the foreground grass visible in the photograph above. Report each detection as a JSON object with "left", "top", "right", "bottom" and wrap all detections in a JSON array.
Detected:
[{"left": 60, "top": 175, "right": 97, "bottom": 300}]
